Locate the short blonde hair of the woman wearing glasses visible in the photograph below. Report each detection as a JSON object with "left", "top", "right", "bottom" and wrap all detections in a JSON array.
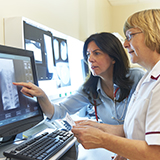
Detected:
[{"left": 123, "top": 9, "right": 160, "bottom": 53}]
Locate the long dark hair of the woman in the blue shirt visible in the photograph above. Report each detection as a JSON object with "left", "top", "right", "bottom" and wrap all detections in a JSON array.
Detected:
[{"left": 82, "top": 32, "right": 133, "bottom": 103}]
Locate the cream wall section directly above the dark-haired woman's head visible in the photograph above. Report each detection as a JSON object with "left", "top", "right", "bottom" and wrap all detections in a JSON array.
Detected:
[{"left": 80, "top": 0, "right": 112, "bottom": 41}]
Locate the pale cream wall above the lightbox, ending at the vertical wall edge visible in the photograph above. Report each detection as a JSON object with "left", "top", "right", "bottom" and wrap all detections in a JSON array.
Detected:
[{"left": 0, "top": 0, "right": 79, "bottom": 43}]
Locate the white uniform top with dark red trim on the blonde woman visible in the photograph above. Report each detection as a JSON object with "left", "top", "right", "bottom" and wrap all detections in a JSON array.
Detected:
[{"left": 124, "top": 61, "right": 160, "bottom": 145}]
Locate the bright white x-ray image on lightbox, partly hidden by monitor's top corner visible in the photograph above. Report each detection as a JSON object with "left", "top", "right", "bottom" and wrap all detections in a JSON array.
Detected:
[{"left": 25, "top": 39, "right": 42, "bottom": 63}]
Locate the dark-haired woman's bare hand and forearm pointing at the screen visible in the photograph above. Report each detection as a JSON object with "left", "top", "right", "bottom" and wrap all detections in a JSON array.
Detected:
[{"left": 13, "top": 82, "right": 54, "bottom": 119}]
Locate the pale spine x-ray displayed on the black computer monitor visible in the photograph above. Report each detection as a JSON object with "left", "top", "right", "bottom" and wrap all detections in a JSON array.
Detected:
[{"left": 0, "top": 59, "right": 20, "bottom": 110}]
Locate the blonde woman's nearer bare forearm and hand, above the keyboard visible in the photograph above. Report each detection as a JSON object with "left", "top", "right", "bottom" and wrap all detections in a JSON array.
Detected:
[{"left": 72, "top": 125, "right": 160, "bottom": 160}]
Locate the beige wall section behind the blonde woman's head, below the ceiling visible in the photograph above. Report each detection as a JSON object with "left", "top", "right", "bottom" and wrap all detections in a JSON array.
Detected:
[{"left": 112, "top": 2, "right": 160, "bottom": 37}]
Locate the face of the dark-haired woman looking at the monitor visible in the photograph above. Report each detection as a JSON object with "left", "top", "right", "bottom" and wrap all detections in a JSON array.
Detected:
[{"left": 87, "top": 41, "right": 115, "bottom": 78}]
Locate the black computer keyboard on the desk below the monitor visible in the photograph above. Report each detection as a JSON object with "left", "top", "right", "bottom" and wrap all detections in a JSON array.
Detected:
[{"left": 3, "top": 130, "right": 74, "bottom": 160}]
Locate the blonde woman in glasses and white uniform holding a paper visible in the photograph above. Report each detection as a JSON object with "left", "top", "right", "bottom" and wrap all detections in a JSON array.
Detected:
[{"left": 72, "top": 9, "right": 160, "bottom": 160}]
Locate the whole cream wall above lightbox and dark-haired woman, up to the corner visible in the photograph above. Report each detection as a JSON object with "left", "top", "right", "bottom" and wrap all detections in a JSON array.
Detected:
[{"left": 0, "top": 0, "right": 111, "bottom": 44}]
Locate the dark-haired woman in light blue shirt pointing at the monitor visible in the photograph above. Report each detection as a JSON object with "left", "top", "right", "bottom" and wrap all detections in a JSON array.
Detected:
[{"left": 14, "top": 32, "right": 144, "bottom": 124}]
